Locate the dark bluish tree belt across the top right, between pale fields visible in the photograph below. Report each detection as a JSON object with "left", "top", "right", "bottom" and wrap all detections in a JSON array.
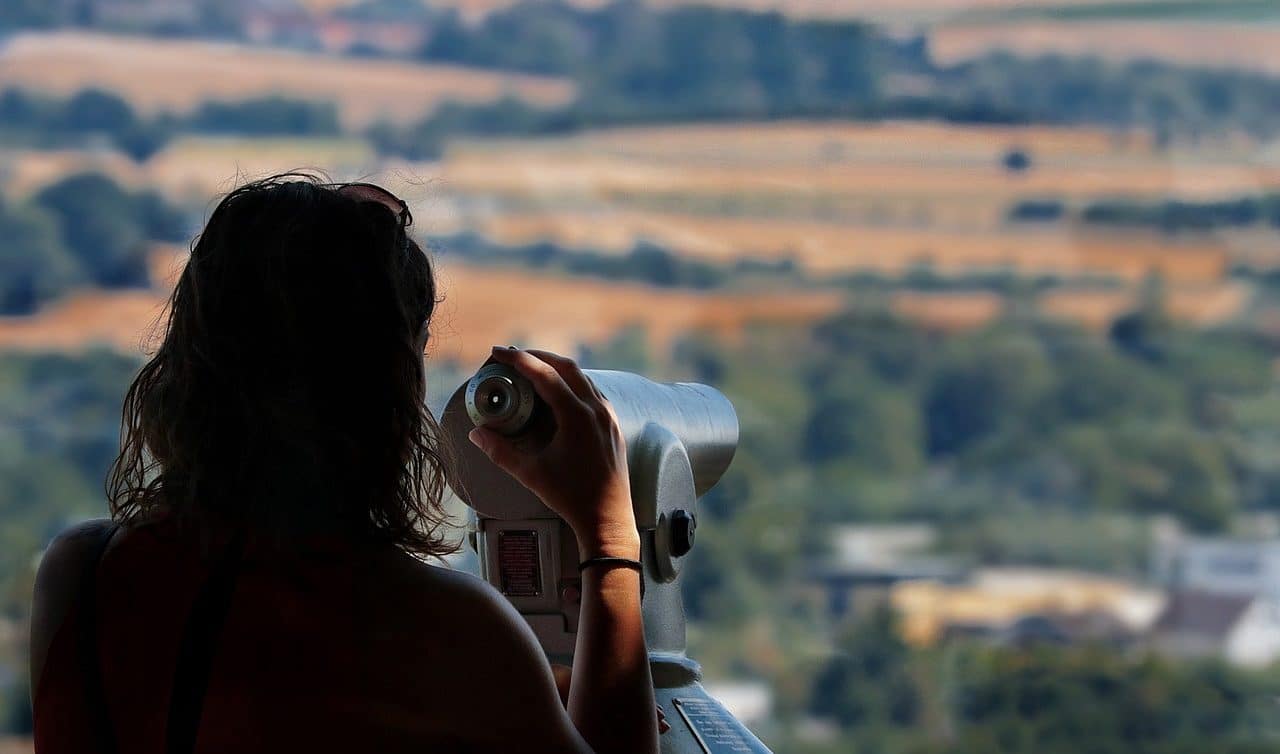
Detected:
[{"left": 371, "top": 0, "right": 1280, "bottom": 155}]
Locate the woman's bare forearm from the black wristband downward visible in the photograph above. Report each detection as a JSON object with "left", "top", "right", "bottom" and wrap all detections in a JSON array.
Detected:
[{"left": 568, "top": 538, "right": 658, "bottom": 754}]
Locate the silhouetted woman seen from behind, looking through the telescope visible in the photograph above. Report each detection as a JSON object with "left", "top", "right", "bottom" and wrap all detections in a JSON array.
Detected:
[{"left": 31, "top": 174, "right": 658, "bottom": 754}]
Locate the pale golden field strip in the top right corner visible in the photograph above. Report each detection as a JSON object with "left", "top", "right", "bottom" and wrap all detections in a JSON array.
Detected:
[{"left": 929, "top": 20, "right": 1280, "bottom": 73}]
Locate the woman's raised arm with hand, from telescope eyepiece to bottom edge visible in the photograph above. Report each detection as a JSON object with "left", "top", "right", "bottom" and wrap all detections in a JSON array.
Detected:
[{"left": 471, "top": 348, "right": 658, "bottom": 754}]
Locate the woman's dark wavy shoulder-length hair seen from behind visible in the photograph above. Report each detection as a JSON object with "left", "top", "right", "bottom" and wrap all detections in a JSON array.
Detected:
[{"left": 106, "top": 173, "right": 457, "bottom": 556}]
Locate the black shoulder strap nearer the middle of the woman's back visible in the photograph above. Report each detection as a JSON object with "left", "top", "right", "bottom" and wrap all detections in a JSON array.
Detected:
[{"left": 165, "top": 535, "right": 244, "bottom": 754}]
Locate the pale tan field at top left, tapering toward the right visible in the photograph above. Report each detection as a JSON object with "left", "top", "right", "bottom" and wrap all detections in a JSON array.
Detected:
[{"left": 0, "top": 32, "right": 573, "bottom": 127}]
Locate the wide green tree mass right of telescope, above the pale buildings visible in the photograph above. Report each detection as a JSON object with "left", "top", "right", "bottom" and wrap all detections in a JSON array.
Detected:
[{"left": 673, "top": 299, "right": 1280, "bottom": 547}]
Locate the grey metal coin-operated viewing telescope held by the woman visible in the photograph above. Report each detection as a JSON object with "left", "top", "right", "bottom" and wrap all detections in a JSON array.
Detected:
[{"left": 442, "top": 362, "right": 768, "bottom": 754}]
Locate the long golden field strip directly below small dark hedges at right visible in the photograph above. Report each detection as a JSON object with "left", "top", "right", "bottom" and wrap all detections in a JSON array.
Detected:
[{"left": 479, "top": 213, "right": 1229, "bottom": 282}]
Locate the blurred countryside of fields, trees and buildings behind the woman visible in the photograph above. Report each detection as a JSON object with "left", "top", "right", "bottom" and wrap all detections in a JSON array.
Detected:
[{"left": 0, "top": 0, "right": 1280, "bottom": 754}]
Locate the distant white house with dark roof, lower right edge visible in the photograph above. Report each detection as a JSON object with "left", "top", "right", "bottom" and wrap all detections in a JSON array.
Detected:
[{"left": 1149, "top": 590, "right": 1280, "bottom": 667}]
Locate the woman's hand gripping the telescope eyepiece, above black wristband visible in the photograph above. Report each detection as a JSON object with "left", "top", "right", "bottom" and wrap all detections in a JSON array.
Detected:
[{"left": 468, "top": 346, "right": 640, "bottom": 558}]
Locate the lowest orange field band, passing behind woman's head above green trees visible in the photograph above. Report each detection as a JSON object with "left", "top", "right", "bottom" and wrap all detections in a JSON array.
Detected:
[{"left": 0, "top": 241, "right": 1249, "bottom": 365}]
